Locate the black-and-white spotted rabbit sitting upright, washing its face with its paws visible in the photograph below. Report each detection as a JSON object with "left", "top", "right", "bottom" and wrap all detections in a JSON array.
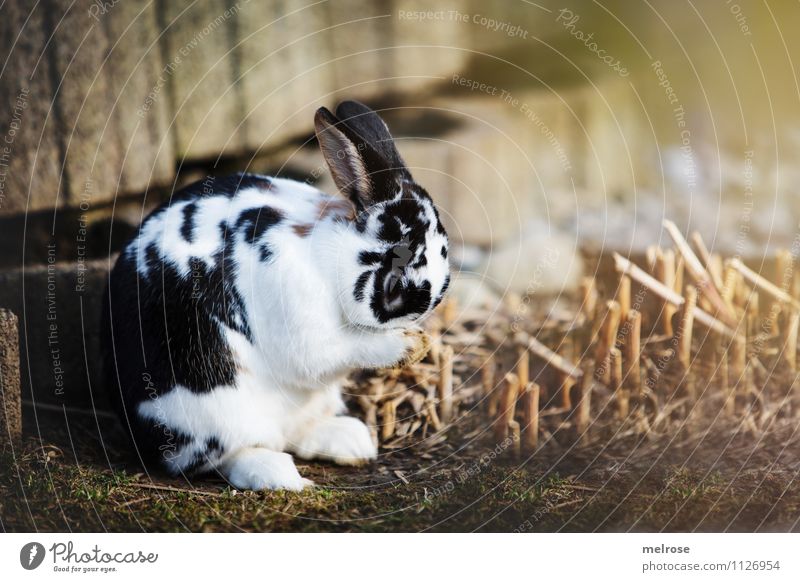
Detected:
[{"left": 102, "top": 101, "right": 450, "bottom": 491}]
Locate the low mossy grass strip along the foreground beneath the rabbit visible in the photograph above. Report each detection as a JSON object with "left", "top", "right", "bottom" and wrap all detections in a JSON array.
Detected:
[{"left": 0, "top": 439, "right": 800, "bottom": 532}]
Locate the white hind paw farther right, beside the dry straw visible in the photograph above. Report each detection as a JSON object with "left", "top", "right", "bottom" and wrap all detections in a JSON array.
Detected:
[{"left": 294, "top": 416, "right": 378, "bottom": 466}]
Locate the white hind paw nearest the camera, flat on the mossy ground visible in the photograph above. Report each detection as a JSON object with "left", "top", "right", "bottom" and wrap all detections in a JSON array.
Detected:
[{"left": 223, "top": 448, "right": 313, "bottom": 491}]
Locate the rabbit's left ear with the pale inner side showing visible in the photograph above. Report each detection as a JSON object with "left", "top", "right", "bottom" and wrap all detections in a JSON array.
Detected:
[{"left": 314, "top": 107, "right": 396, "bottom": 210}]
